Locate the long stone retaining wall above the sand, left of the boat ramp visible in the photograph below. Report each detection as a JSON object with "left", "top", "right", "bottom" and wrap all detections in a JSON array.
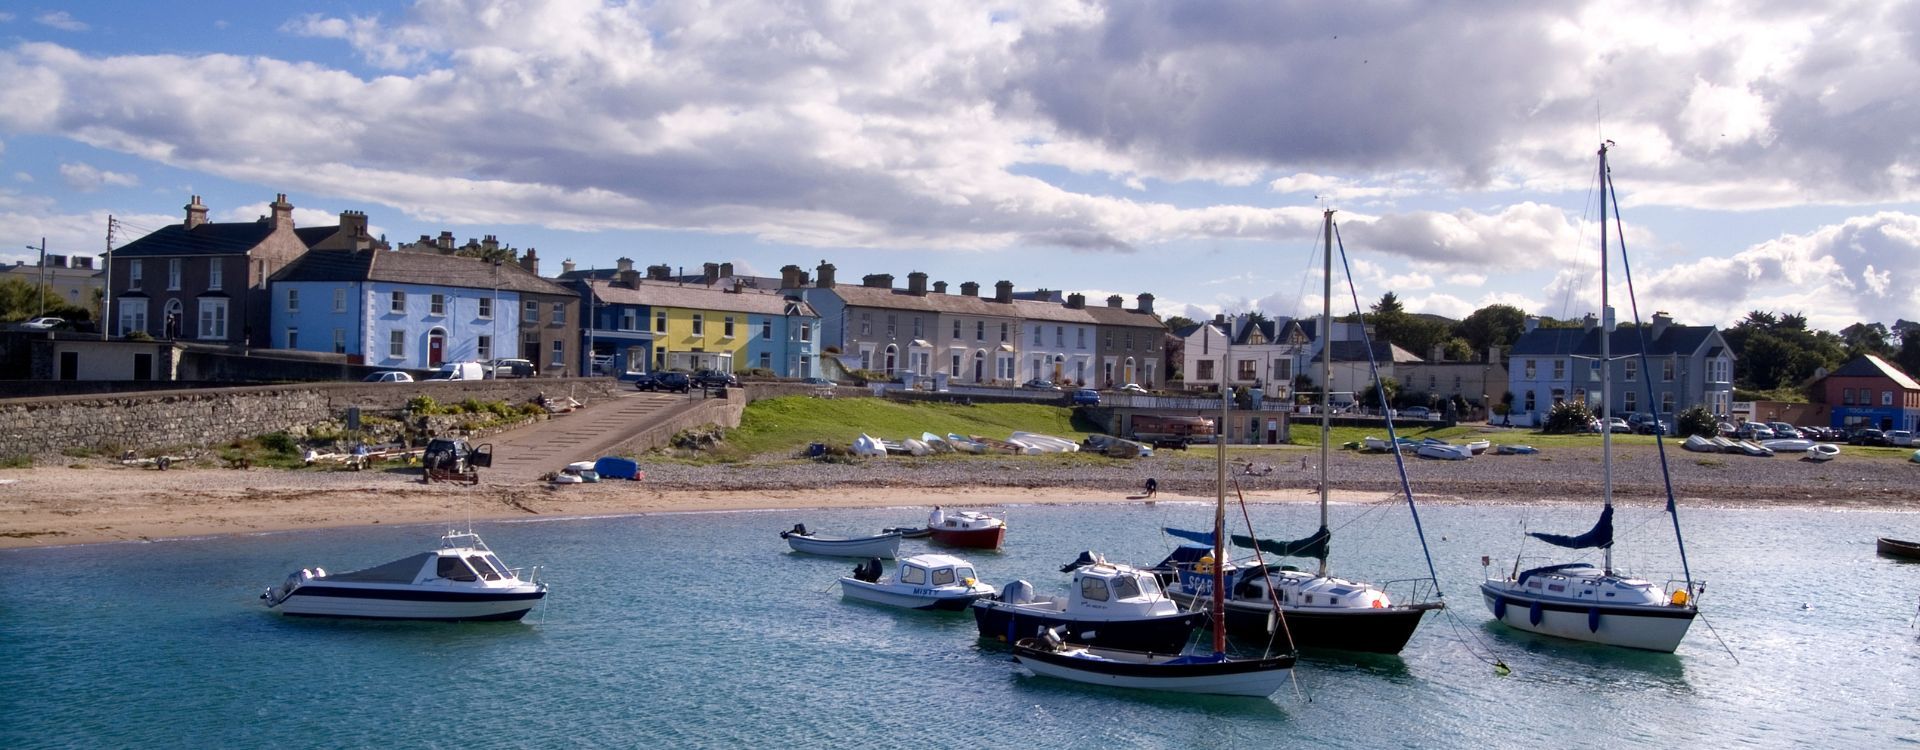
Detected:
[{"left": 0, "top": 378, "right": 618, "bottom": 457}]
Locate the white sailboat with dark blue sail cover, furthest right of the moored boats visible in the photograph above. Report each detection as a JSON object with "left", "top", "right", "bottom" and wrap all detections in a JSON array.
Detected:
[{"left": 1480, "top": 142, "right": 1705, "bottom": 652}]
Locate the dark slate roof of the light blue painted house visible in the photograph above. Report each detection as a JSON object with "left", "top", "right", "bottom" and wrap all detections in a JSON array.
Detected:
[{"left": 273, "top": 249, "right": 576, "bottom": 297}]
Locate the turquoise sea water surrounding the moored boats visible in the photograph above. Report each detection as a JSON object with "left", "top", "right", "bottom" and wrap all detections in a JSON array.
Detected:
[{"left": 0, "top": 503, "right": 1920, "bottom": 748}]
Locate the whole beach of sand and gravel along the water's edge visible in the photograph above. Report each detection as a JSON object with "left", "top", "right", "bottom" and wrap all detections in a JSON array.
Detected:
[{"left": 0, "top": 447, "right": 1920, "bottom": 549}]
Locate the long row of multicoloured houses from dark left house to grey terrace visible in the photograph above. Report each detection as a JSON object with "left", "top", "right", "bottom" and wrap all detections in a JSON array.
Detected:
[{"left": 108, "top": 194, "right": 1165, "bottom": 381}]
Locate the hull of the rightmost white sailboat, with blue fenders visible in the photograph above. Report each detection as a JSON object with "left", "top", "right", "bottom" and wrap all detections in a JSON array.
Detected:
[{"left": 1480, "top": 583, "right": 1699, "bottom": 654}]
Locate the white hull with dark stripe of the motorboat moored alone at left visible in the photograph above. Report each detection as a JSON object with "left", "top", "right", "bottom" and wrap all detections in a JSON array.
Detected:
[{"left": 276, "top": 583, "right": 547, "bottom": 621}]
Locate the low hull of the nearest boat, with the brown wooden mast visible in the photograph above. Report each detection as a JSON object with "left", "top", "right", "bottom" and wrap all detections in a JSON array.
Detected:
[{"left": 1014, "top": 639, "right": 1294, "bottom": 698}]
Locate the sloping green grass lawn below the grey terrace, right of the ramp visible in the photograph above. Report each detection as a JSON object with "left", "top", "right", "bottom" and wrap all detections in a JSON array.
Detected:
[{"left": 726, "top": 395, "right": 1100, "bottom": 455}]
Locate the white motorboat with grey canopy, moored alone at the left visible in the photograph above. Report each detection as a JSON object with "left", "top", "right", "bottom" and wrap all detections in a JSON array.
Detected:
[{"left": 259, "top": 531, "right": 547, "bottom": 621}]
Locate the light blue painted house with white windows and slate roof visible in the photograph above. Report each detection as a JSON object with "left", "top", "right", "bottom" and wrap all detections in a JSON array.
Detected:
[{"left": 271, "top": 249, "right": 576, "bottom": 374}]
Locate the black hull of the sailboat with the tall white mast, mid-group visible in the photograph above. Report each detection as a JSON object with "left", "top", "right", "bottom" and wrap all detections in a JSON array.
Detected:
[{"left": 1167, "top": 593, "right": 1440, "bottom": 654}]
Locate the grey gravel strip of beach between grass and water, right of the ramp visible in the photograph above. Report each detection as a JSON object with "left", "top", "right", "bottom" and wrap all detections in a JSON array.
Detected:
[{"left": 641, "top": 447, "right": 1920, "bottom": 506}]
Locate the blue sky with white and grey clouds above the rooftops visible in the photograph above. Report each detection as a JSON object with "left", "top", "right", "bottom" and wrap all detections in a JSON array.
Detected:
[{"left": 0, "top": 0, "right": 1920, "bottom": 330}]
